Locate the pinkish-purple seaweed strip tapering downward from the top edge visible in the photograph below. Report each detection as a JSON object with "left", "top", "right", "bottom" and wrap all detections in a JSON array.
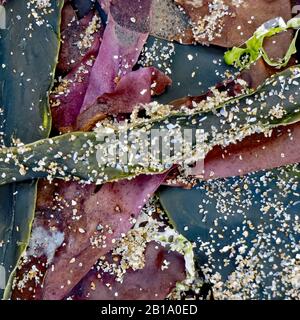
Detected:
[{"left": 82, "top": 0, "right": 151, "bottom": 111}]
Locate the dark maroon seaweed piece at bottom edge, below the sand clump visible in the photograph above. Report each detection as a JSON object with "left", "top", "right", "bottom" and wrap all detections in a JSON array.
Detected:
[{"left": 70, "top": 242, "right": 186, "bottom": 300}]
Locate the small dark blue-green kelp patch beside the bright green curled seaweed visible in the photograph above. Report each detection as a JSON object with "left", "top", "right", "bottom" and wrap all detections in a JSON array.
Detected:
[{"left": 140, "top": 36, "right": 235, "bottom": 103}]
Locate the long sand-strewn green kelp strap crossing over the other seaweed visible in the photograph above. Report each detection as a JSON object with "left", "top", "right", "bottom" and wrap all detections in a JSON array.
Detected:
[{"left": 0, "top": 67, "right": 300, "bottom": 185}]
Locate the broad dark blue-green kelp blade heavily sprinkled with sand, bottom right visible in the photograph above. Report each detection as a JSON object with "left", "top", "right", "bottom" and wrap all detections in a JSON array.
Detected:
[{"left": 159, "top": 165, "right": 300, "bottom": 299}]
